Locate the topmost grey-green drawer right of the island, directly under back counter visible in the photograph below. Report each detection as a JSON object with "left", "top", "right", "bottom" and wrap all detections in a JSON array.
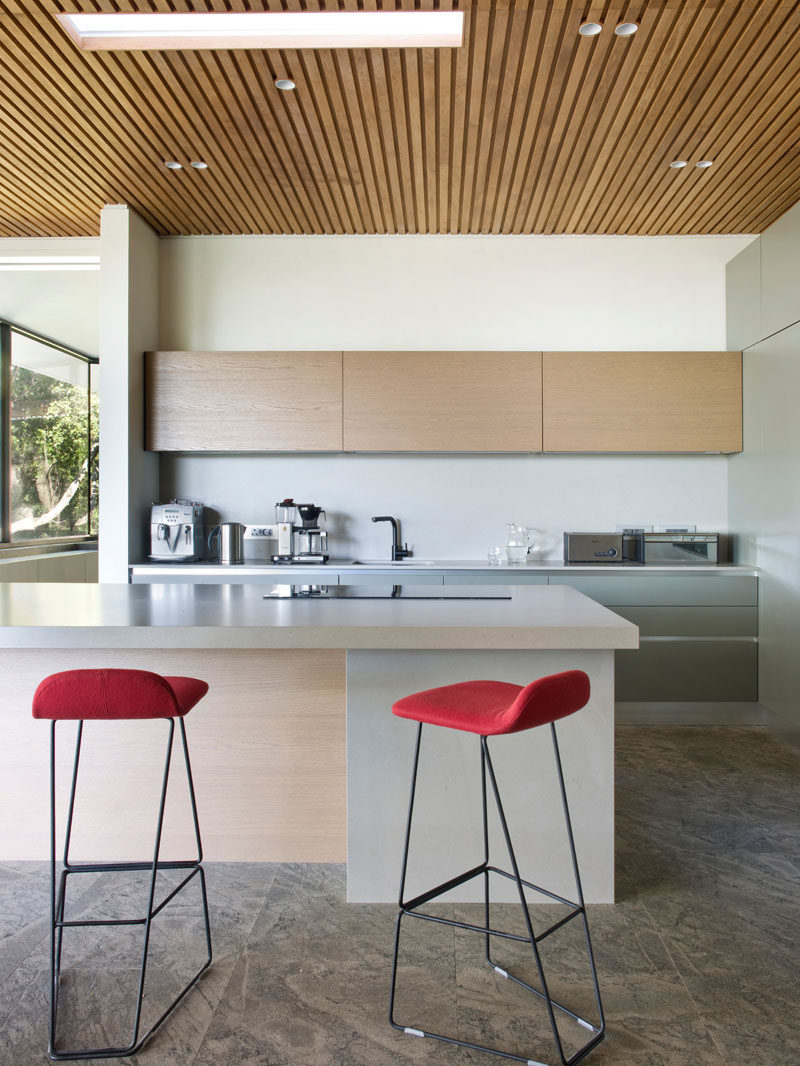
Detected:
[{"left": 550, "top": 574, "right": 758, "bottom": 607}]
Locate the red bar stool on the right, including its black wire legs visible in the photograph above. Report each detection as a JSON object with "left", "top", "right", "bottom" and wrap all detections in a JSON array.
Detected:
[{"left": 389, "top": 671, "right": 606, "bottom": 1066}]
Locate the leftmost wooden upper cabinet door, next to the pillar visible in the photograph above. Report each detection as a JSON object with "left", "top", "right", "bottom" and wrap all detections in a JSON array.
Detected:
[{"left": 146, "top": 352, "right": 341, "bottom": 452}]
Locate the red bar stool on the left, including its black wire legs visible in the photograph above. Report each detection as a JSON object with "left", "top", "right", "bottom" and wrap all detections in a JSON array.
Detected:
[{"left": 33, "top": 669, "right": 211, "bottom": 1060}]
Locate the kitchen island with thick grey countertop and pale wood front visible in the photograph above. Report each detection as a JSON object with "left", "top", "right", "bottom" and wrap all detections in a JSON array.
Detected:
[{"left": 0, "top": 584, "right": 638, "bottom": 902}]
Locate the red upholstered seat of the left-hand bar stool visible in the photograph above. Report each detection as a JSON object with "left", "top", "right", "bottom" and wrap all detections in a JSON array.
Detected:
[{"left": 33, "top": 669, "right": 208, "bottom": 721}]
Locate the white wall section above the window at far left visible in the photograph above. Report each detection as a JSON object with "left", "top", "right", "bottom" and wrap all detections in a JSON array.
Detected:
[{"left": 0, "top": 237, "right": 100, "bottom": 355}]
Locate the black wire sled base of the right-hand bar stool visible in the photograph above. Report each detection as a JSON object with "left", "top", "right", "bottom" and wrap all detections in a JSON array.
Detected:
[{"left": 389, "top": 722, "right": 606, "bottom": 1066}]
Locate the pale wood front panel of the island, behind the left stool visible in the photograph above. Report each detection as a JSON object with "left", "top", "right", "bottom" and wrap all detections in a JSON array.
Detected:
[{"left": 0, "top": 647, "right": 347, "bottom": 862}]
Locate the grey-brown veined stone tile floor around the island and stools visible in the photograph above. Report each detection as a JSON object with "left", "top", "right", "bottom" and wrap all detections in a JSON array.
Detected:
[{"left": 0, "top": 727, "right": 800, "bottom": 1066}]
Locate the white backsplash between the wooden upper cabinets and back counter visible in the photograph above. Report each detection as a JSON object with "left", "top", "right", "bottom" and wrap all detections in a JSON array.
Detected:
[{"left": 160, "top": 455, "right": 727, "bottom": 560}]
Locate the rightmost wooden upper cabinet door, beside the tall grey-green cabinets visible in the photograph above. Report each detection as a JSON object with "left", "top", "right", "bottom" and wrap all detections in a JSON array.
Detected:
[{"left": 543, "top": 352, "right": 741, "bottom": 452}]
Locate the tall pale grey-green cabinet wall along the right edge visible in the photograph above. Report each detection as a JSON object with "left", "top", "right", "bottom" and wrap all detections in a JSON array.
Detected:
[{"left": 727, "top": 207, "right": 800, "bottom": 741}]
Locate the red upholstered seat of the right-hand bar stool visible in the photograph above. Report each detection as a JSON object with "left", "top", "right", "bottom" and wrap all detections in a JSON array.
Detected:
[{"left": 391, "top": 669, "right": 591, "bottom": 737}]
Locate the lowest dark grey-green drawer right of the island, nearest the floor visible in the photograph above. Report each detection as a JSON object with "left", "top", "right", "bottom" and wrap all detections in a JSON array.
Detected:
[{"left": 614, "top": 637, "right": 758, "bottom": 702}]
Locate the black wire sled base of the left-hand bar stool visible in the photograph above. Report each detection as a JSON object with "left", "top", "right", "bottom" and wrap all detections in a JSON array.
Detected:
[{"left": 48, "top": 717, "right": 211, "bottom": 1061}]
